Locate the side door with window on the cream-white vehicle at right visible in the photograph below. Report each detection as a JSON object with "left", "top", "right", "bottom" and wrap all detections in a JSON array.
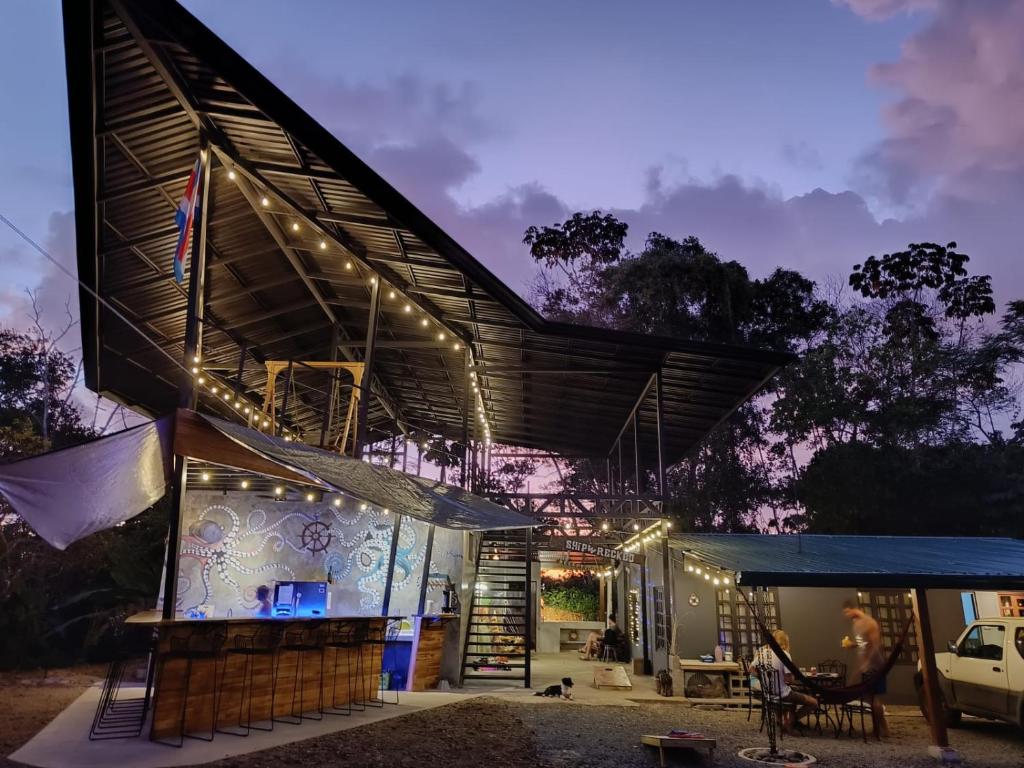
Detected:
[{"left": 950, "top": 624, "right": 1011, "bottom": 717}]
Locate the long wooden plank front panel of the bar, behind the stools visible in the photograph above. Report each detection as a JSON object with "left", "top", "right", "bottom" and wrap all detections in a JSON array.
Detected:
[{"left": 149, "top": 616, "right": 388, "bottom": 739}]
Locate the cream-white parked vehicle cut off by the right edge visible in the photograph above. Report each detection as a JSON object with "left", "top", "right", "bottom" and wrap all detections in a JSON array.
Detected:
[{"left": 915, "top": 618, "right": 1024, "bottom": 727}]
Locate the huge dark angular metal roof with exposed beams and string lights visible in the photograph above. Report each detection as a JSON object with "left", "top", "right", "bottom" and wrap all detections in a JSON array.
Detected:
[{"left": 63, "top": 0, "right": 790, "bottom": 460}]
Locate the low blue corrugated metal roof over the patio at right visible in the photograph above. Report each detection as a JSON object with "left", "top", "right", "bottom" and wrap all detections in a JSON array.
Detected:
[{"left": 669, "top": 534, "right": 1024, "bottom": 589}]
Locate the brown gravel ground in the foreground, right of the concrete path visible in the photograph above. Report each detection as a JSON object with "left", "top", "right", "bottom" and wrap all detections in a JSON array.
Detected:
[{"left": 186, "top": 697, "right": 1024, "bottom": 768}]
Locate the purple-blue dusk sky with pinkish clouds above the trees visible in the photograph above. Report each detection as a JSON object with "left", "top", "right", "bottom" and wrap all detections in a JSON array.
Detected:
[{"left": 0, "top": 0, "right": 1024, "bottom": 335}]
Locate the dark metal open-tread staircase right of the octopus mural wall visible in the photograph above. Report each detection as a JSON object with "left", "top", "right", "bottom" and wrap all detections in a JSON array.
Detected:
[{"left": 462, "top": 530, "right": 532, "bottom": 688}]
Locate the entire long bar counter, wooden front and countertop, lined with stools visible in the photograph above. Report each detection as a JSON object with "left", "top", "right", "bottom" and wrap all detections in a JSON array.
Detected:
[{"left": 142, "top": 611, "right": 400, "bottom": 740}]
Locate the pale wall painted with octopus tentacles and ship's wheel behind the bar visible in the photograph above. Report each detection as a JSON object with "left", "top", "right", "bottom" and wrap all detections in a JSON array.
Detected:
[{"left": 177, "top": 490, "right": 463, "bottom": 616}]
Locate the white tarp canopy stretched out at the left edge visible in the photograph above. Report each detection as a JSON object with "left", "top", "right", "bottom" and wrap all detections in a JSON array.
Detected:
[{"left": 0, "top": 417, "right": 174, "bottom": 550}]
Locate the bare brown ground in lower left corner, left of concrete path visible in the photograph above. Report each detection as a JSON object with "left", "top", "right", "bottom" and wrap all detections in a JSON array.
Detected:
[{"left": 0, "top": 665, "right": 105, "bottom": 768}]
